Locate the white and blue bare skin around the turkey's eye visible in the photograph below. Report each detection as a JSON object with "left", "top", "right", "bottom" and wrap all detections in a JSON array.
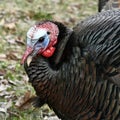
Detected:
[{"left": 27, "top": 28, "right": 50, "bottom": 56}]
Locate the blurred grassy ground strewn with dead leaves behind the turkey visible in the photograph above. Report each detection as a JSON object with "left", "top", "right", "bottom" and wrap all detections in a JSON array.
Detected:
[{"left": 0, "top": 0, "right": 97, "bottom": 120}]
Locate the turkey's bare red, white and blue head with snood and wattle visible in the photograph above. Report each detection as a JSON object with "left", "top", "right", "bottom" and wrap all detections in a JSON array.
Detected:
[{"left": 22, "top": 22, "right": 59, "bottom": 63}]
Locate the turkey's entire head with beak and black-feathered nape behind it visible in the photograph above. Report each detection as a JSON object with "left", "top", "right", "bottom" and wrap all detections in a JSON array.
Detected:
[{"left": 21, "top": 21, "right": 72, "bottom": 65}]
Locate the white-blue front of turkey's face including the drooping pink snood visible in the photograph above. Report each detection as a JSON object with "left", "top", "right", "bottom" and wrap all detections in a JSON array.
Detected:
[{"left": 21, "top": 26, "right": 50, "bottom": 64}]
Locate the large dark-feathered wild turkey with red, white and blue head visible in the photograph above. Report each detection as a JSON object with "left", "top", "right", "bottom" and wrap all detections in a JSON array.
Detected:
[{"left": 22, "top": 0, "right": 120, "bottom": 120}]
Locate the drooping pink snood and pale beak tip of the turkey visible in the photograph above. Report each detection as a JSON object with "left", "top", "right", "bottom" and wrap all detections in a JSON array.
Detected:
[{"left": 21, "top": 46, "right": 33, "bottom": 66}]
